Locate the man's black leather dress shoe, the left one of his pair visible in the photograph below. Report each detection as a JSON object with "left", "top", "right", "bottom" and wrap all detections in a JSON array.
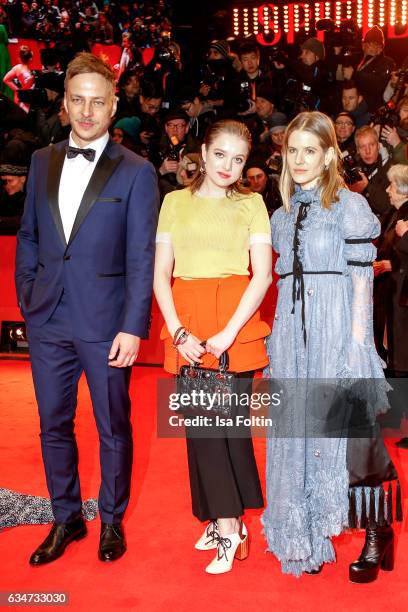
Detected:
[{"left": 30, "top": 517, "right": 86, "bottom": 565}]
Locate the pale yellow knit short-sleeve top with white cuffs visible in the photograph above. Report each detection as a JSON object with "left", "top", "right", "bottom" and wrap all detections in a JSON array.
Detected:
[{"left": 156, "top": 189, "right": 271, "bottom": 279}]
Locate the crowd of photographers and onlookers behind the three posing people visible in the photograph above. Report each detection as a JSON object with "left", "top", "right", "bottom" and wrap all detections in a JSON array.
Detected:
[{"left": 0, "top": 17, "right": 408, "bottom": 215}]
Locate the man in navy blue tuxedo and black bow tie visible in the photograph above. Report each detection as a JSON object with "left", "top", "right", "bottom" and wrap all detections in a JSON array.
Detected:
[{"left": 16, "top": 53, "right": 158, "bottom": 565}]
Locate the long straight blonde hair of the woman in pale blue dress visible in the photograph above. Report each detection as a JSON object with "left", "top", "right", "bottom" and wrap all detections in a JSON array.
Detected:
[{"left": 279, "top": 111, "right": 346, "bottom": 212}]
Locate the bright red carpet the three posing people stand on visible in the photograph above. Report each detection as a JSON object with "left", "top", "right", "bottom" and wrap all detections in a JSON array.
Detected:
[{"left": 0, "top": 361, "right": 408, "bottom": 612}]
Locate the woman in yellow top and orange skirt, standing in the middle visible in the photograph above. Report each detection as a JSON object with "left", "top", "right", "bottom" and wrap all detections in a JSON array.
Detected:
[{"left": 154, "top": 120, "right": 272, "bottom": 574}]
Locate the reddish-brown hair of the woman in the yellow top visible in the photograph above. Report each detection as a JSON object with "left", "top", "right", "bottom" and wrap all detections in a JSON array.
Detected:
[{"left": 190, "top": 119, "right": 252, "bottom": 196}]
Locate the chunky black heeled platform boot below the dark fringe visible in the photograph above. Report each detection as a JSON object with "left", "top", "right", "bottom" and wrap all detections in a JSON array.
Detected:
[{"left": 349, "top": 525, "right": 394, "bottom": 583}]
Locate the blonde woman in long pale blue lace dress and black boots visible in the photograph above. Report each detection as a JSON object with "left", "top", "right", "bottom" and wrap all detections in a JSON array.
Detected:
[{"left": 262, "top": 112, "right": 402, "bottom": 582}]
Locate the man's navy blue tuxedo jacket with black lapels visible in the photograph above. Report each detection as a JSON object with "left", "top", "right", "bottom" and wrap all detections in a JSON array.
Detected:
[{"left": 16, "top": 141, "right": 159, "bottom": 342}]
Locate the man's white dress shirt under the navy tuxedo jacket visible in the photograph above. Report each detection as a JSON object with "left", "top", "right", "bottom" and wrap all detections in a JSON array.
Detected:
[{"left": 58, "top": 132, "right": 109, "bottom": 242}]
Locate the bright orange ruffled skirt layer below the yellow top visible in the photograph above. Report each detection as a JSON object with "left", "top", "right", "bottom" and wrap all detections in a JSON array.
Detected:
[{"left": 160, "top": 276, "right": 271, "bottom": 374}]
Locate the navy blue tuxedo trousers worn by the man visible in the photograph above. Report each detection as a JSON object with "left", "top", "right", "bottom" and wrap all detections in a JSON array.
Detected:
[{"left": 28, "top": 290, "right": 133, "bottom": 523}]
